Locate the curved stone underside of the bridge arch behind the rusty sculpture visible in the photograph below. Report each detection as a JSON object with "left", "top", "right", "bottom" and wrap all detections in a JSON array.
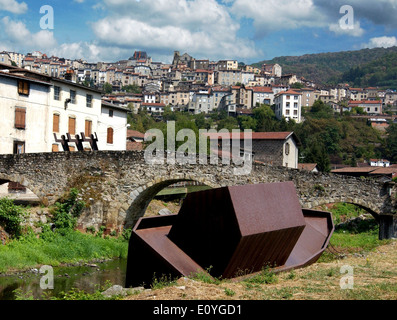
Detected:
[{"left": 125, "top": 175, "right": 221, "bottom": 228}]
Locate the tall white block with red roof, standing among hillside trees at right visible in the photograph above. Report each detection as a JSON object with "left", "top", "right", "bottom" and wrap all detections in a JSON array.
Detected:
[{"left": 274, "top": 90, "right": 302, "bottom": 123}]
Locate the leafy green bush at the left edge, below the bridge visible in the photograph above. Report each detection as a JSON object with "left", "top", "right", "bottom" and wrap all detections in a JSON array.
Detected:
[{"left": 0, "top": 198, "right": 27, "bottom": 238}]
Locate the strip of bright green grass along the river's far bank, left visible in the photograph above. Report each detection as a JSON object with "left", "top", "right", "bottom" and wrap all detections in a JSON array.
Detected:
[{"left": 0, "top": 231, "right": 128, "bottom": 273}]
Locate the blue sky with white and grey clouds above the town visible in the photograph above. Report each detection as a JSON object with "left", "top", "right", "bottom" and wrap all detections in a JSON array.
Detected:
[{"left": 0, "top": 0, "right": 397, "bottom": 64}]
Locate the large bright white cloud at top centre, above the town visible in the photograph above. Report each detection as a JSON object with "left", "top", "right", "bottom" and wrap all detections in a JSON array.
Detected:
[{"left": 92, "top": 0, "right": 261, "bottom": 59}]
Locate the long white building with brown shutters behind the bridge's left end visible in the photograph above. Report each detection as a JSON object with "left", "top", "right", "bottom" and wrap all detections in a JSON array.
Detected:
[{"left": 0, "top": 65, "right": 127, "bottom": 154}]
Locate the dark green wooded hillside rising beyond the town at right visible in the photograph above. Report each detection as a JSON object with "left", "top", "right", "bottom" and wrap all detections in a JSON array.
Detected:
[{"left": 253, "top": 47, "right": 397, "bottom": 84}]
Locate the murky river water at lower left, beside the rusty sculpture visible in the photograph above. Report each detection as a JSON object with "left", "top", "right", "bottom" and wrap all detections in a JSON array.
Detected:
[{"left": 0, "top": 259, "right": 127, "bottom": 300}]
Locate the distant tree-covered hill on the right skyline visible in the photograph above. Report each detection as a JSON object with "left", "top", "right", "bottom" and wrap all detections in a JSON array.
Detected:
[{"left": 253, "top": 47, "right": 397, "bottom": 86}]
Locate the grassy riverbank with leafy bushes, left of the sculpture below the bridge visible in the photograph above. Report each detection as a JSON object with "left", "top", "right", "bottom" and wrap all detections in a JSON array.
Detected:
[{"left": 0, "top": 189, "right": 129, "bottom": 273}]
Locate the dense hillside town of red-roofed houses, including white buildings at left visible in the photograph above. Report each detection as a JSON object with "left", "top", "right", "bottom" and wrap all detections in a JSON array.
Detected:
[{"left": 0, "top": 51, "right": 397, "bottom": 170}]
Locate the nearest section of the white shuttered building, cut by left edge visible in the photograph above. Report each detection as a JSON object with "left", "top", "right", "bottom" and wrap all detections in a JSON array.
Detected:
[{"left": 0, "top": 65, "right": 51, "bottom": 154}]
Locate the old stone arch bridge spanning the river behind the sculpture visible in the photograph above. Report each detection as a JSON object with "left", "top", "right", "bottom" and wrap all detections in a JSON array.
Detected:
[{"left": 0, "top": 151, "right": 397, "bottom": 238}]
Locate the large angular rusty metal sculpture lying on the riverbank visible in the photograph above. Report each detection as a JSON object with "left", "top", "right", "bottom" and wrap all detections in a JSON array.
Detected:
[{"left": 126, "top": 182, "right": 334, "bottom": 287}]
